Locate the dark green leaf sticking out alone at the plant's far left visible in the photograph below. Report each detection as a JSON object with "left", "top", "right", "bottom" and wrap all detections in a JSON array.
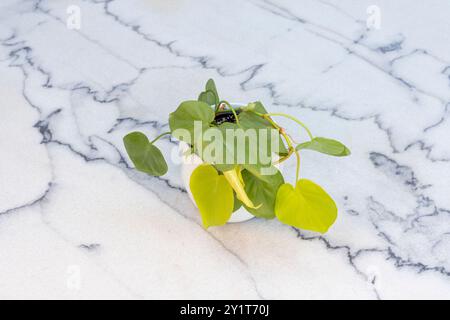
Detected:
[{"left": 123, "top": 132, "right": 167, "bottom": 176}]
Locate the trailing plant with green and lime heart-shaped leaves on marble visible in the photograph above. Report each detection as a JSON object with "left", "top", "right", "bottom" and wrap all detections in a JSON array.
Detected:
[{"left": 124, "top": 79, "right": 350, "bottom": 233}]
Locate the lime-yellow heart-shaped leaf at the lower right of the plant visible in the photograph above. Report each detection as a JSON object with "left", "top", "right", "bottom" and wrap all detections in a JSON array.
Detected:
[{"left": 275, "top": 179, "right": 337, "bottom": 233}]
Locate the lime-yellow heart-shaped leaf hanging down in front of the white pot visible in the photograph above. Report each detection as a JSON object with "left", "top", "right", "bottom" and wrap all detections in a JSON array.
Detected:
[{"left": 189, "top": 164, "right": 234, "bottom": 228}]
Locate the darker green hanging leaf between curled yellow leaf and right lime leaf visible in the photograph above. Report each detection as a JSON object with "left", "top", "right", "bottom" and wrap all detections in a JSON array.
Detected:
[{"left": 242, "top": 170, "right": 284, "bottom": 219}]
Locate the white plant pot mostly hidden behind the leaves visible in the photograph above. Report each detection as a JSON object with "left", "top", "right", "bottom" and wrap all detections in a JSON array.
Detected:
[{"left": 179, "top": 141, "right": 254, "bottom": 223}]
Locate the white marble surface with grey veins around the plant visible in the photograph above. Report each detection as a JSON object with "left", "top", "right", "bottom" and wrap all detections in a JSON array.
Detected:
[{"left": 0, "top": 0, "right": 450, "bottom": 299}]
